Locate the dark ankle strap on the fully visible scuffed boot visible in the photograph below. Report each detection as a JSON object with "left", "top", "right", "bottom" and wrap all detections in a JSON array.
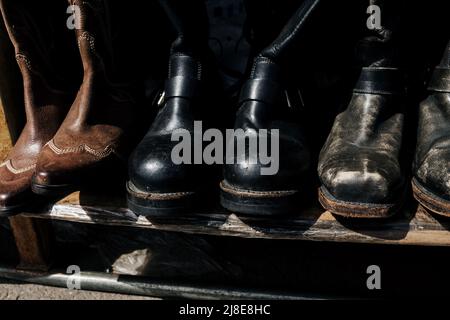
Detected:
[{"left": 353, "top": 68, "right": 405, "bottom": 95}]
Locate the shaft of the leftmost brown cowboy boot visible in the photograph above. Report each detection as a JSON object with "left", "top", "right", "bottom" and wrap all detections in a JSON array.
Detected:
[{"left": 0, "top": 0, "right": 79, "bottom": 133}]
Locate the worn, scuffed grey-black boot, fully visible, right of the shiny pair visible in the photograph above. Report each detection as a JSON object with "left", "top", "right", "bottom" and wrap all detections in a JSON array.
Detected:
[{"left": 318, "top": 1, "right": 405, "bottom": 218}]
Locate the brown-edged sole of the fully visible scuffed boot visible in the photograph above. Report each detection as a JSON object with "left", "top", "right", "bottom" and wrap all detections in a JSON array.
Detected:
[{"left": 319, "top": 186, "right": 401, "bottom": 219}]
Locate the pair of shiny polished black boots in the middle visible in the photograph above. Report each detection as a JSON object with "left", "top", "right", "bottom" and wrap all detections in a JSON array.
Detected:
[{"left": 127, "top": 0, "right": 320, "bottom": 215}]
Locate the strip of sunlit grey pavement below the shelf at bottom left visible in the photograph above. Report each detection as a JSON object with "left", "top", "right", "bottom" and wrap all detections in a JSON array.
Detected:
[{"left": 0, "top": 279, "right": 156, "bottom": 300}]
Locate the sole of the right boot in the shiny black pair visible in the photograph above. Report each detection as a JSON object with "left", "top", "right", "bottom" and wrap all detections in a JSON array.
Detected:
[{"left": 220, "top": 181, "right": 300, "bottom": 216}]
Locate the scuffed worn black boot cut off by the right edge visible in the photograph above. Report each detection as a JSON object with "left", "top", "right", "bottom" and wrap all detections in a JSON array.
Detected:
[{"left": 413, "top": 39, "right": 450, "bottom": 217}]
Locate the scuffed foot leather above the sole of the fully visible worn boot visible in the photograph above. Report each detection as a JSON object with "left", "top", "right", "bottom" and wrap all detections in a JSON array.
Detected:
[{"left": 318, "top": 93, "right": 404, "bottom": 204}]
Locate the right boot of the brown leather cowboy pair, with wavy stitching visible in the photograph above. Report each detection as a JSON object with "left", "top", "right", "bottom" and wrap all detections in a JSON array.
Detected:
[{"left": 32, "top": 0, "right": 135, "bottom": 196}]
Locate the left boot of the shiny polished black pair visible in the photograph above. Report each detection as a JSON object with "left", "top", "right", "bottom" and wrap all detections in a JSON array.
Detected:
[{"left": 127, "top": 0, "right": 220, "bottom": 216}]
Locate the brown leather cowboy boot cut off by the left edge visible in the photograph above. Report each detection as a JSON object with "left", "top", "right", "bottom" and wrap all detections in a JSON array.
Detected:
[{"left": 0, "top": 0, "right": 73, "bottom": 214}]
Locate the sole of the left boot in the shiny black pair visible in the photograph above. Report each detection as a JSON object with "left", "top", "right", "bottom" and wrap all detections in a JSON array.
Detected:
[{"left": 127, "top": 182, "right": 198, "bottom": 217}]
